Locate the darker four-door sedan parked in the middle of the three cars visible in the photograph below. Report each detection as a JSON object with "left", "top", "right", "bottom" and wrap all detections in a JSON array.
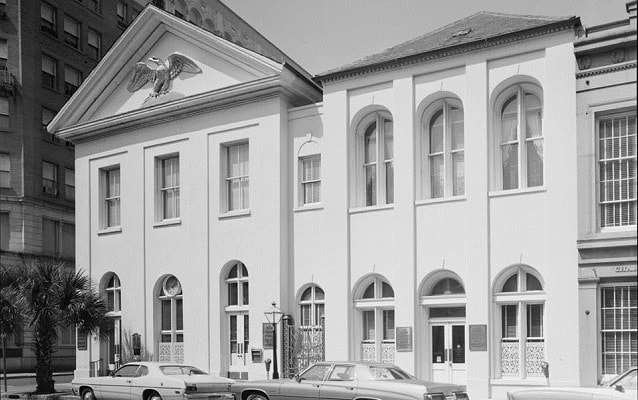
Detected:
[{"left": 232, "top": 361, "right": 469, "bottom": 400}]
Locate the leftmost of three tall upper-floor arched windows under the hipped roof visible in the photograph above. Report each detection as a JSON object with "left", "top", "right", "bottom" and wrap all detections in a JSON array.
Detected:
[{"left": 355, "top": 112, "right": 394, "bottom": 206}]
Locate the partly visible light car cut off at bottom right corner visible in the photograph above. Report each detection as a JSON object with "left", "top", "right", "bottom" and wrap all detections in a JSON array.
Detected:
[{"left": 507, "top": 367, "right": 637, "bottom": 400}]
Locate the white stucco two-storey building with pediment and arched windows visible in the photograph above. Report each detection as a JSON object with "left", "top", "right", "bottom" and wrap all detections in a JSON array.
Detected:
[{"left": 49, "top": 6, "right": 635, "bottom": 399}]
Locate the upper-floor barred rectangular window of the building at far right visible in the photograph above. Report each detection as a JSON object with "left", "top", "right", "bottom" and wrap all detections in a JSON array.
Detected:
[{"left": 597, "top": 111, "right": 636, "bottom": 228}]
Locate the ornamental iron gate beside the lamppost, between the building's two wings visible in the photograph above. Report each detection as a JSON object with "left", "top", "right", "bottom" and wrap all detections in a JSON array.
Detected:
[{"left": 282, "top": 317, "right": 325, "bottom": 378}]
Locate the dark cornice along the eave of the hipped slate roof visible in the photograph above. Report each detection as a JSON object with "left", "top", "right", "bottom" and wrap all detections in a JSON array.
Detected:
[{"left": 316, "top": 17, "right": 580, "bottom": 84}]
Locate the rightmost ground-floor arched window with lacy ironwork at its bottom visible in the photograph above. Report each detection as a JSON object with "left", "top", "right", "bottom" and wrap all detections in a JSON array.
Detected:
[{"left": 494, "top": 266, "right": 545, "bottom": 379}]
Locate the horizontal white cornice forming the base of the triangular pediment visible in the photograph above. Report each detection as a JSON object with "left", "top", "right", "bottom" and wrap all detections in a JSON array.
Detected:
[{"left": 56, "top": 75, "right": 292, "bottom": 143}]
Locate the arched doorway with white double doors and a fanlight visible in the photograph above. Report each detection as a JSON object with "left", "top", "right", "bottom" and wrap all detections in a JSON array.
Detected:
[{"left": 420, "top": 271, "right": 467, "bottom": 385}]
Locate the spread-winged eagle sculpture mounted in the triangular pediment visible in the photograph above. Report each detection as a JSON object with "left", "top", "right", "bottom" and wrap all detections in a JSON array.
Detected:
[{"left": 126, "top": 53, "right": 202, "bottom": 97}]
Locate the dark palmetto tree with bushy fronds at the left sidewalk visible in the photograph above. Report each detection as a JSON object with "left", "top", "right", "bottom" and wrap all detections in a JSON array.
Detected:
[{"left": 6, "top": 261, "right": 109, "bottom": 393}]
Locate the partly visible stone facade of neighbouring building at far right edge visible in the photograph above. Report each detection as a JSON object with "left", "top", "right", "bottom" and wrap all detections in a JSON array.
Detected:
[{"left": 575, "top": 1, "right": 638, "bottom": 386}]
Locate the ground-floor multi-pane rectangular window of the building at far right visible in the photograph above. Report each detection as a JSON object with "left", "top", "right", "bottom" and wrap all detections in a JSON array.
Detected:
[{"left": 600, "top": 285, "right": 638, "bottom": 375}]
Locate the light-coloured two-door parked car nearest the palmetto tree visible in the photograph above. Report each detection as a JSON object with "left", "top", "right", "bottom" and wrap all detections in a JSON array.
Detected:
[{"left": 71, "top": 362, "right": 235, "bottom": 400}]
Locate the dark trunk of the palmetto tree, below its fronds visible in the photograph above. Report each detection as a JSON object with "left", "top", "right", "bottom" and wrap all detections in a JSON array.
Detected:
[{"left": 33, "top": 318, "right": 56, "bottom": 393}]
